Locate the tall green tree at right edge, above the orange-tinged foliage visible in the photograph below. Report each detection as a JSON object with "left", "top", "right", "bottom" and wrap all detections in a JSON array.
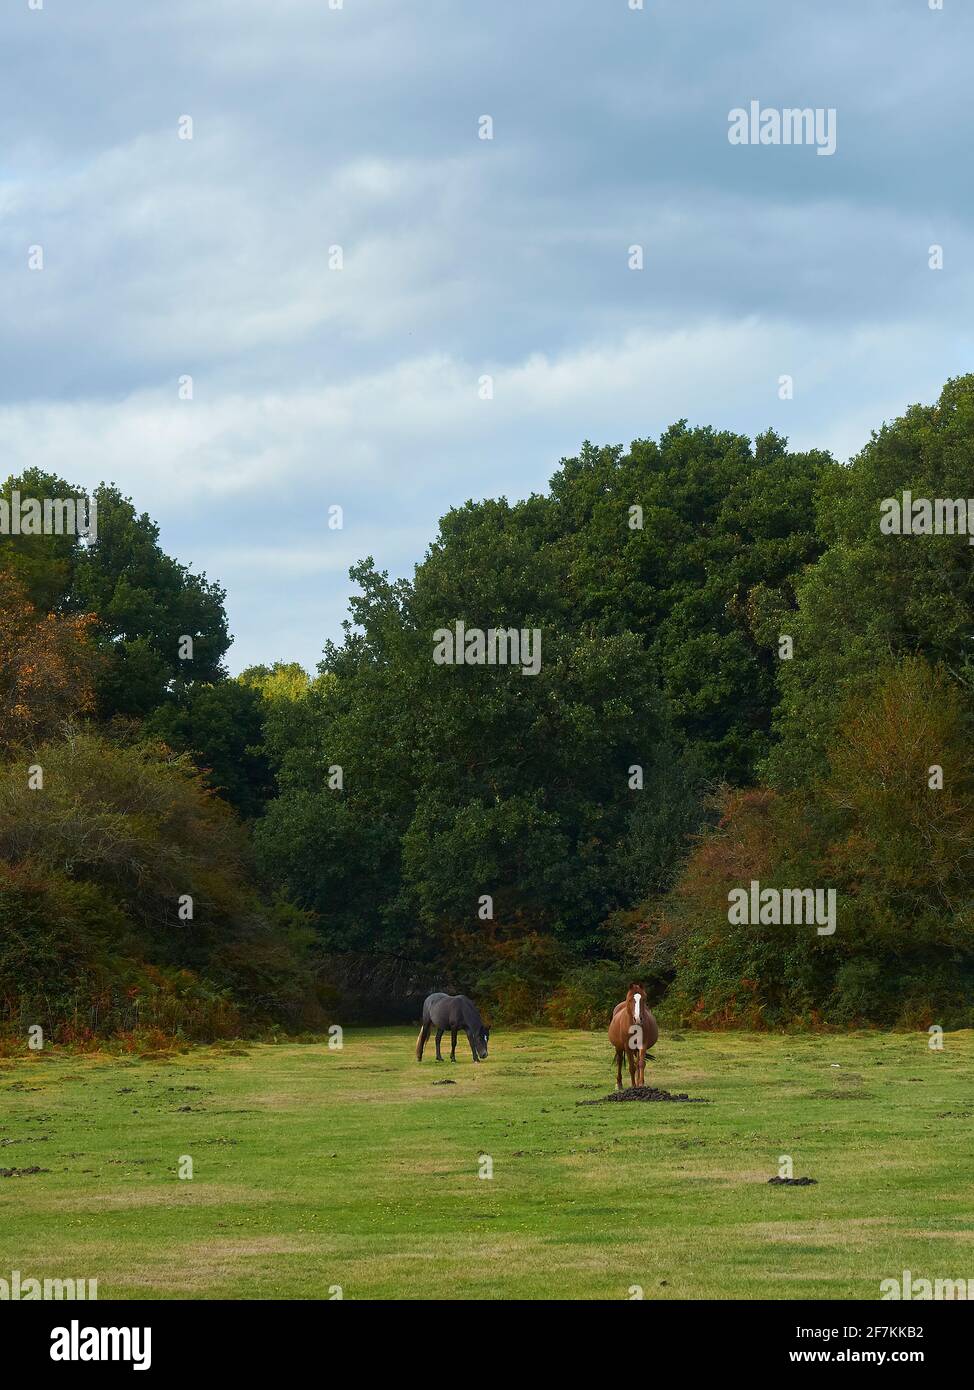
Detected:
[{"left": 767, "top": 375, "right": 974, "bottom": 787}]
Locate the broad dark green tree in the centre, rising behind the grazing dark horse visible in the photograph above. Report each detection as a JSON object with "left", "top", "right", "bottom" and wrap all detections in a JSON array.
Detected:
[{"left": 256, "top": 542, "right": 693, "bottom": 955}]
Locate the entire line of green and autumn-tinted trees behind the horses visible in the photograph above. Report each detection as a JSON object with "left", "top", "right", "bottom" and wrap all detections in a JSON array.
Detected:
[{"left": 0, "top": 377, "right": 974, "bottom": 1038}]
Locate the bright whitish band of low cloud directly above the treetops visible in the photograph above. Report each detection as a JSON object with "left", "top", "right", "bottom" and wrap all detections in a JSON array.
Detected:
[{"left": 0, "top": 317, "right": 943, "bottom": 667}]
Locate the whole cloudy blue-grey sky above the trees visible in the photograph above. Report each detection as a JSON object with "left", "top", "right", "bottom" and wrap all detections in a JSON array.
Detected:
[{"left": 0, "top": 0, "right": 974, "bottom": 671}]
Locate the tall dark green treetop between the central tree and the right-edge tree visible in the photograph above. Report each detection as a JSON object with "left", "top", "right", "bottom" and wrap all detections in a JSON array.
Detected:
[{"left": 550, "top": 421, "right": 831, "bottom": 784}]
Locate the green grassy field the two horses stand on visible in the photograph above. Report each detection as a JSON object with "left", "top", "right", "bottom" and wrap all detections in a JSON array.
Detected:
[{"left": 0, "top": 1029, "right": 974, "bottom": 1300}]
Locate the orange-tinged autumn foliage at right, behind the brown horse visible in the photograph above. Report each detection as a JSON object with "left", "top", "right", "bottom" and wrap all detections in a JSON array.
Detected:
[{"left": 634, "top": 657, "right": 974, "bottom": 1027}]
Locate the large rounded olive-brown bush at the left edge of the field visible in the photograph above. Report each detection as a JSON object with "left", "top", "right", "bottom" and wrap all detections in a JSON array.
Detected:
[{"left": 0, "top": 734, "right": 321, "bottom": 1037}]
